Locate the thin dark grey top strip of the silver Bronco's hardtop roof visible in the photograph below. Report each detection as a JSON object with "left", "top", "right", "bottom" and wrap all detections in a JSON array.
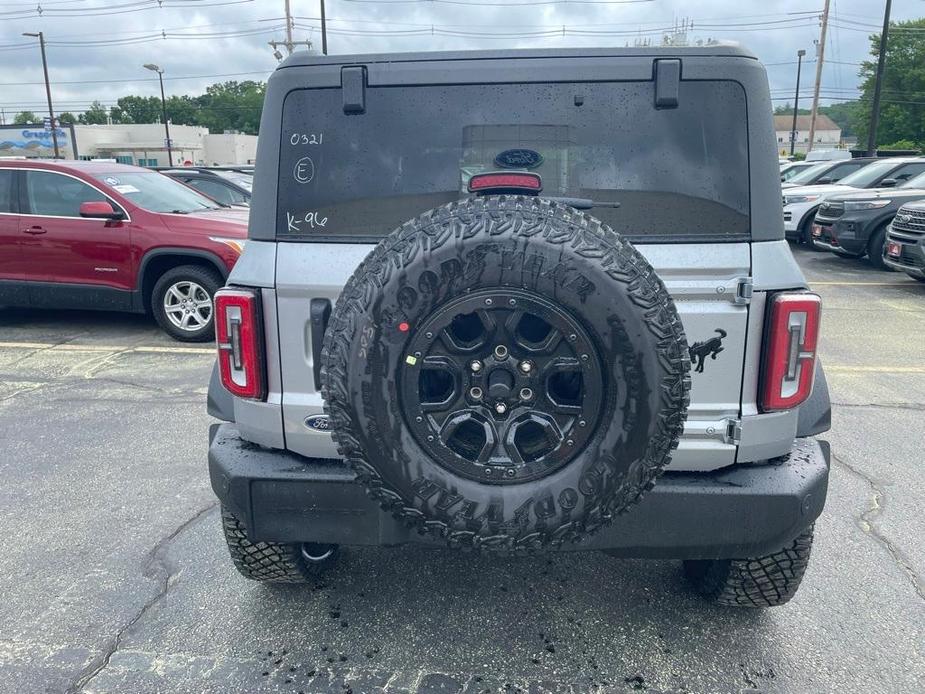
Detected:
[{"left": 277, "top": 42, "right": 758, "bottom": 70}]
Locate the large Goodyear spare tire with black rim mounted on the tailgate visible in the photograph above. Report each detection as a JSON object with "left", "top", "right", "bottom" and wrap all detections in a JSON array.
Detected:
[{"left": 321, "top": 196, "right": 690, "bottom": 552}]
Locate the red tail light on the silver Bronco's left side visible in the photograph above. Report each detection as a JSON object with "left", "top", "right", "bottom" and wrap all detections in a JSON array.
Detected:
[{"left": 215, "top": 289, "right": 267, "bottom": 400}]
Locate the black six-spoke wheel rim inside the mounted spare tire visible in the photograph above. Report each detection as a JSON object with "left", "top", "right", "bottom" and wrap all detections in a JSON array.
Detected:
[{"left": 399, "top": 289, "right": 604, "bottom": 484}]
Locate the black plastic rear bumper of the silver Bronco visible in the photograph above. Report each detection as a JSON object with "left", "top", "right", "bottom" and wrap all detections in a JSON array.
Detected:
[{"left": 209, "top": 424, "right": 829, "bottom": 559}]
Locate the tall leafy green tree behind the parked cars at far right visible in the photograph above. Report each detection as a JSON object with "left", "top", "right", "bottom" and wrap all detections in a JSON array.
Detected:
[{"left": 854, "top": 18, "right": 925, "bottom": 147}]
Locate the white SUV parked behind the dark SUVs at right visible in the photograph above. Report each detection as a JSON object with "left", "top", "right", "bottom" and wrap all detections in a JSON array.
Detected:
[{"left": 783, "top": 157, "right": 925, "bottom": 244}]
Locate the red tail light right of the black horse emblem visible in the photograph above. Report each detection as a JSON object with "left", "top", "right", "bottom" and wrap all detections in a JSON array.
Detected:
[{"left": 761, "top": 292, "right": 822, "bottom": 412}]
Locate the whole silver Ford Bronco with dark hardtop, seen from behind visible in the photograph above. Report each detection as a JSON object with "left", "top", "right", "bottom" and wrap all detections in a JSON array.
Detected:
[{"left": 209, "top": 46, "right": 830, "bottom": 606}]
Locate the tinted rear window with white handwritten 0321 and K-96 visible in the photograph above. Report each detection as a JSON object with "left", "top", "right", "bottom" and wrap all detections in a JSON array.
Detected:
[{"left": 277, "top": 81, "right": 749, "bottom": 241}]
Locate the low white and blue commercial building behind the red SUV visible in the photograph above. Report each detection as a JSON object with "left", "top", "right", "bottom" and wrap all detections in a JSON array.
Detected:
[{"left": 0, "top": 123, "right": 257, "bottom": 166}]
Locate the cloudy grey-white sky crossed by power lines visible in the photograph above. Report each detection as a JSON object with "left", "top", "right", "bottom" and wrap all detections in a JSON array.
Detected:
[{"left": 0, "top": 0, "right": 912, "bottom": 122}]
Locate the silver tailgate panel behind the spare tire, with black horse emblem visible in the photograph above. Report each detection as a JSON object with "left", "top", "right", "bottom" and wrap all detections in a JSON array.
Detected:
[{"left": 276, "top": 243, "right": 750, "bottom": 470}]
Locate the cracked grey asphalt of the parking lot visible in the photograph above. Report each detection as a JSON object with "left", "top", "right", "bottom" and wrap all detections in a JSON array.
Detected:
[{"left": 0, "top": 246, "right": 925, "bottom": 694}]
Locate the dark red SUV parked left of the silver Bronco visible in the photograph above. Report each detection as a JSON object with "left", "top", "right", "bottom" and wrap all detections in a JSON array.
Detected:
[{"left": 0, "top": 160, "right": 247, "bottom": 342}]
